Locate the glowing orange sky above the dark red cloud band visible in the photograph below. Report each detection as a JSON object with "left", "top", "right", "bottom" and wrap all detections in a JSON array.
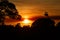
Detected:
[{"left": 10, "top": 0, "right": 60, "bottom": 17}]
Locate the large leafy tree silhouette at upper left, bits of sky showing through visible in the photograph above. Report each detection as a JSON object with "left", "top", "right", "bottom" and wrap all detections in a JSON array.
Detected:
[{"left": 0, "top": 0, "right": 21, "bottom": 23}]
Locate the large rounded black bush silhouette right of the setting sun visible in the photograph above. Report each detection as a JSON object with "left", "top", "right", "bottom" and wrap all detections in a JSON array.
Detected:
[{"left": 32, "top": 18, "right": 54, "bottom": 32}]
